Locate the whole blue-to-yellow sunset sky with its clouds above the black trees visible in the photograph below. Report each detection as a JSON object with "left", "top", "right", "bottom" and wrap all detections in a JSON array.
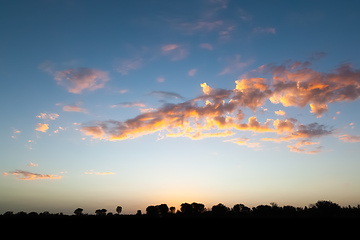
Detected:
[{"left": 0, "top": 0, "right": 360, "bottom": 214}]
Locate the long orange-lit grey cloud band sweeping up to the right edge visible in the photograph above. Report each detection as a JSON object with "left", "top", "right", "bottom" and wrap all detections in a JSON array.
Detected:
[{"left": 81, "top": 61, "right": 360, "bottom": 153}]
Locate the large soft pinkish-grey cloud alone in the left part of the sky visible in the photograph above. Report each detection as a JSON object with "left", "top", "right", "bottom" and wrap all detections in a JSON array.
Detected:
[{"left": 54, "top": 67, "right": 109, "bottom": 94}]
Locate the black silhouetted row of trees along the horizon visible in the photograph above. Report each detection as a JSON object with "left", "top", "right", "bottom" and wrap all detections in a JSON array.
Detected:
[{"left": 0, "top": 201, "right": 360, "bottom": 219}]
